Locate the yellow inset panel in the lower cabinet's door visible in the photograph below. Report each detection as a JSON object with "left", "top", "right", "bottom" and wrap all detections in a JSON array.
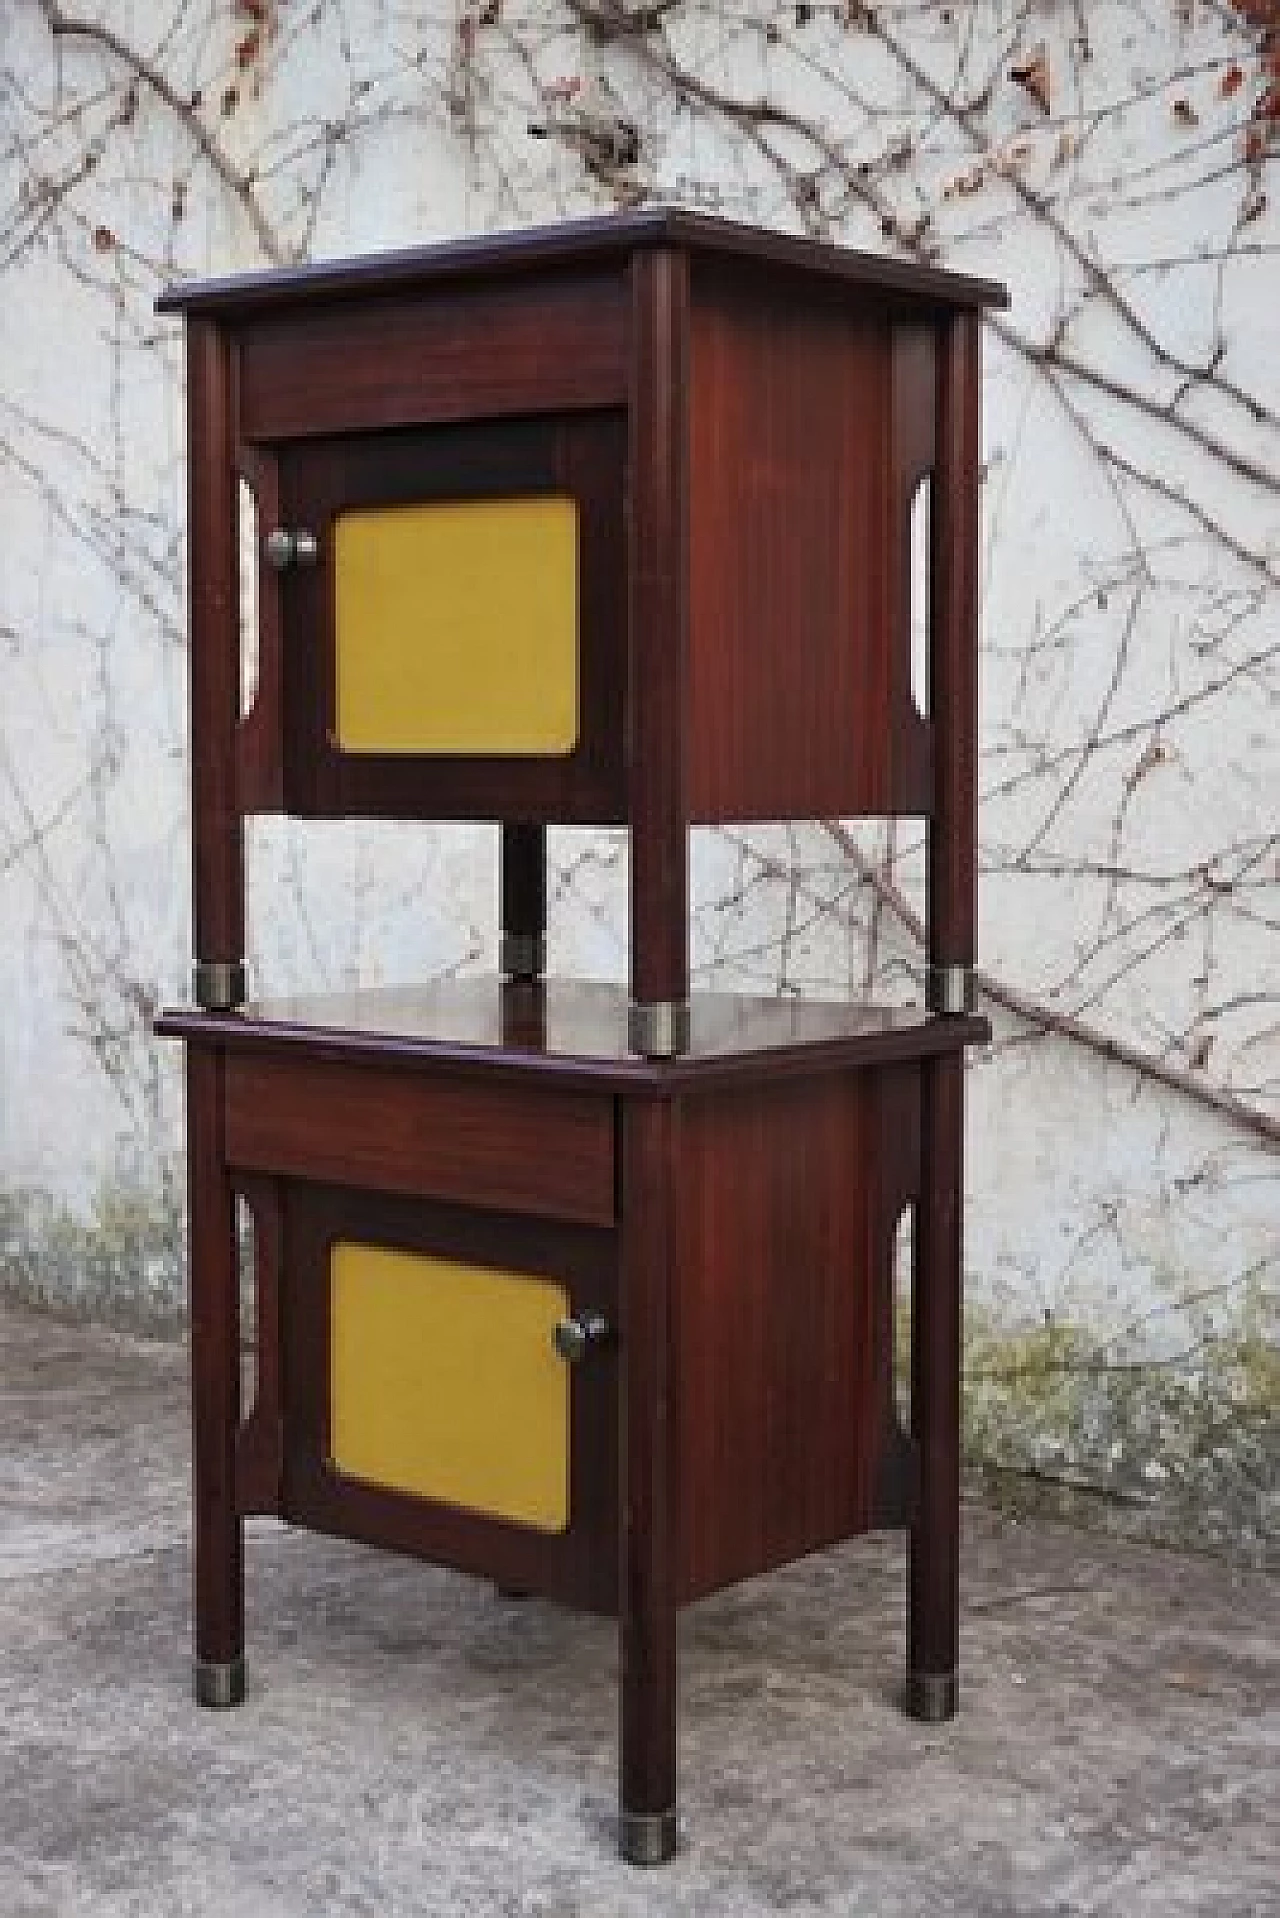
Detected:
[{"left": 330, "top": 1241, "right": 570, "bottom": 1532}]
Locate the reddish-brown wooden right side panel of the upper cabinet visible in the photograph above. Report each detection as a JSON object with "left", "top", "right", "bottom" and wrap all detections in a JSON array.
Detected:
[{"left": 689, "top": 269, "right": 925, "bottom": 821}]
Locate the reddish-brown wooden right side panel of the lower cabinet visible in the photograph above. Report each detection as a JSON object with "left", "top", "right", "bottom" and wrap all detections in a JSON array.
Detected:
[{"left": 676, "top": 1074, "right": 906, "bottom": 1600}]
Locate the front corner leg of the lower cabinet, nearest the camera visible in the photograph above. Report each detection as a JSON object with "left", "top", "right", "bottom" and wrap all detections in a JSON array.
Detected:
[{"left": 618, "top": 1099, "right": 676, "bottom": 1864}]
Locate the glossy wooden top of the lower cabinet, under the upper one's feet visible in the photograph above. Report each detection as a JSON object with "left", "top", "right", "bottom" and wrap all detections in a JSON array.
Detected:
[{"left": 155, "top": 978, "right": 990, "bottom": 1089}]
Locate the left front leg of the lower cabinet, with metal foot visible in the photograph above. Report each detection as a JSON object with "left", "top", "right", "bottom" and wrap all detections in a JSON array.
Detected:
[{"left": 186, "top": 1045, "right": 244, "bottom": 1705}]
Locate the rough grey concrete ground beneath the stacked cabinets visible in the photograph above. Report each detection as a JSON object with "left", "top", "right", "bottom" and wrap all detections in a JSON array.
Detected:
[{"left": 0, "top": 1308, "right": 1280, "bottom": 1918}]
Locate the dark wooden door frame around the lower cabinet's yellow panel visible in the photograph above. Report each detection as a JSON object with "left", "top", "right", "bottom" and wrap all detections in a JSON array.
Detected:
[{"left": 280, "top": 1180, "right": 618, "bottom": 1613}]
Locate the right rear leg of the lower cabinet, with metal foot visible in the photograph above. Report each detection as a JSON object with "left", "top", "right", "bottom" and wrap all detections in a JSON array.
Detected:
[{"left": 906, "top": 1055, "right": 963, "bottom": 1722}]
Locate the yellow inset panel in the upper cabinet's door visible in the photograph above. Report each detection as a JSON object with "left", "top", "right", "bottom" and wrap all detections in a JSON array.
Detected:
[{"left": 334, "top": 497, "right": 578, "bottom": 756}]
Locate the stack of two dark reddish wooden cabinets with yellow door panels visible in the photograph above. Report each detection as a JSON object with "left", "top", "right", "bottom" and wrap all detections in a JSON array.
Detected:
[{"left": 157, "top": 211, "right": 1004, "bottom": 1862}]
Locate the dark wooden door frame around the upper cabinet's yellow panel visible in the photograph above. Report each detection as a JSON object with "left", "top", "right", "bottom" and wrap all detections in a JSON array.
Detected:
[{"left": 246, "top": 409, "right": 628, "bottom": 825}]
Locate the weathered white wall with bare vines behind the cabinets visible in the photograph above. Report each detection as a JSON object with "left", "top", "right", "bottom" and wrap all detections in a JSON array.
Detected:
[{"left": 0, "top": 0, "right": 1280, "bottom": 1557}]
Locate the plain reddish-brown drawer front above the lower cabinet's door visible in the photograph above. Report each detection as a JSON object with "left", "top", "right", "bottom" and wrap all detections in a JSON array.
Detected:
[{"left": 226, "top": 1051, "right": 614, "bottom": 1226}]
